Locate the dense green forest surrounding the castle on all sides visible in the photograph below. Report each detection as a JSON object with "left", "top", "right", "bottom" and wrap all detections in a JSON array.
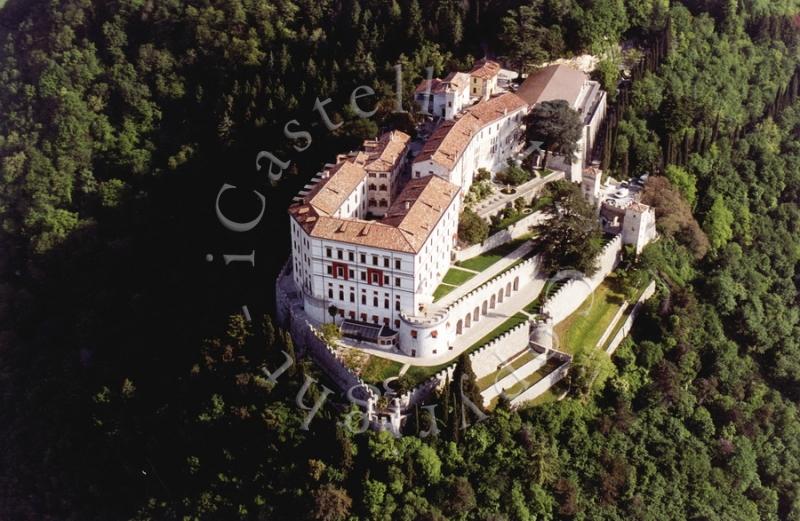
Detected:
[{"left": 0, "top": 0, "right": 800, "bottom": 521}]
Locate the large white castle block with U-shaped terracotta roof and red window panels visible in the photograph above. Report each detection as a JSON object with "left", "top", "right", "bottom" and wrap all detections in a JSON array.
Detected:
[{"left": 289, "top": 132, "right": 459, "bottom": 352}]
